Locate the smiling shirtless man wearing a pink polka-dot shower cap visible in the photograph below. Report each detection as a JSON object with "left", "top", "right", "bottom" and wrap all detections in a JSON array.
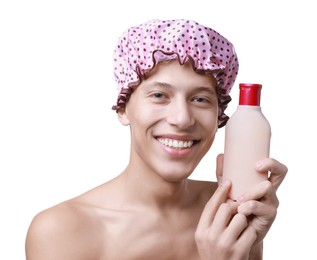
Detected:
[{"left": 26, "top": 20, "right": 287, "bottom": 260}]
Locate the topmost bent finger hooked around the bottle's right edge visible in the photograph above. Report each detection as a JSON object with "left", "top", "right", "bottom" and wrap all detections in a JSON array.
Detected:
[{"left": 256, "top": 158, "right": 288, "bottom": 190}]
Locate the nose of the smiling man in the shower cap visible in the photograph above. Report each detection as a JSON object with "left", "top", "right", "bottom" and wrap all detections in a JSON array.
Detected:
[{"left": 166, "top": 99, "right": 195, "bottom": 129}]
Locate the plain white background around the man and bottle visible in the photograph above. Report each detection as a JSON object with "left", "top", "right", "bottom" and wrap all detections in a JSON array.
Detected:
[{"left": 0, "top": 0, "right": 317, "bottom": 260}]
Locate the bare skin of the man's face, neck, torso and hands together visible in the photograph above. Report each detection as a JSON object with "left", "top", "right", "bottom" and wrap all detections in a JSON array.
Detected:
[{"left": 26, "top": 61, "right": 287, "bottom": 260}]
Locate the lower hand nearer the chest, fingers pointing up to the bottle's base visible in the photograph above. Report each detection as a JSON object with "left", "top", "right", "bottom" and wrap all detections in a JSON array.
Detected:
[{"left": 195, "top": 153, "right": 257, "bottom": 260}]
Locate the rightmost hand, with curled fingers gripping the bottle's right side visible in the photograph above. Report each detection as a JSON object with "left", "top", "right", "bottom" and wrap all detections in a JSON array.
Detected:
[{"left": 238, "top": 158, "right": 288, "bottom": 242}]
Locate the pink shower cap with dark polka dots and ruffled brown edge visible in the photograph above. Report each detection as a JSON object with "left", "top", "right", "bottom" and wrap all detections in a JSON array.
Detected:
[{"left": 112, "top": 19, "right": 239, "bottom": 127}]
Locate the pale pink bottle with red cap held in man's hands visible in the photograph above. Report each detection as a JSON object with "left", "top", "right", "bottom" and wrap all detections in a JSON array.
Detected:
[{"left": 223, "top": 83, "right": 271, "bottom": 200}]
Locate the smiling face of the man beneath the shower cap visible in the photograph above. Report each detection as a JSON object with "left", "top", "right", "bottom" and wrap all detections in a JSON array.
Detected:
[{"left": 118, "top": 60, "right": 218, "bottom": 183}]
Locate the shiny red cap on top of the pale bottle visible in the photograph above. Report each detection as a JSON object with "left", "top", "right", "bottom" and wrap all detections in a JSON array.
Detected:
[{"left": 239, "top": 83, "right": 262, "bottom": 106}]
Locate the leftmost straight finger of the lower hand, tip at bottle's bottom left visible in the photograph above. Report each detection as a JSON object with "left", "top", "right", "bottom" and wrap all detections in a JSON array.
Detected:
[{"left": 197, "top": 180, "right": 231, "bottom": 229}]
